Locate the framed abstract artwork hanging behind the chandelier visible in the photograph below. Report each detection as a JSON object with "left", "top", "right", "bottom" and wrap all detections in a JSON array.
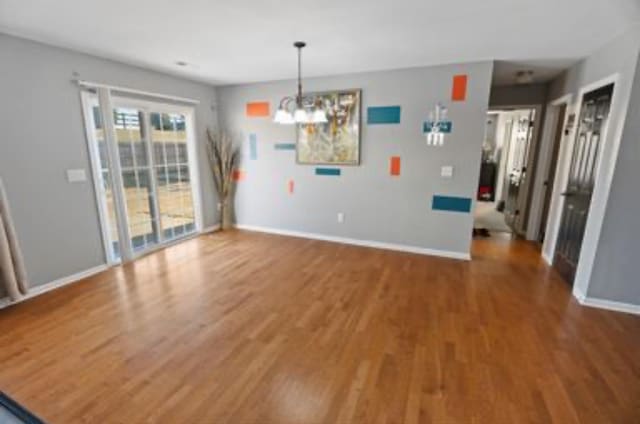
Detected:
[{"left": 296, "top": 89, "right": 362, "bottom": 165}]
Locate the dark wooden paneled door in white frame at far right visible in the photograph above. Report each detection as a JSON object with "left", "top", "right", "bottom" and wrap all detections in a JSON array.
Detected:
[{"left": 553, "top": 84, "right": 613, "bottom": 284}]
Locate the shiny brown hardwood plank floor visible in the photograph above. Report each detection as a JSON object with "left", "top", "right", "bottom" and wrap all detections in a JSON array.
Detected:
[{"left": 0, "top": 232, "right": 640, "bottom": 424}]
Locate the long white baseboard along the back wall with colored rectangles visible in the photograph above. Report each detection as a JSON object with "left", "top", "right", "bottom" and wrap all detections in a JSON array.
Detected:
[{"left": 236, "top": 224, "right": 471, "bottom": 261}]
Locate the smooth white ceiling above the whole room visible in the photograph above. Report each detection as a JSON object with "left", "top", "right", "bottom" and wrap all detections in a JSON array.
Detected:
[{"left": 0, "top": 0, "right": 640, "bottom": 84}]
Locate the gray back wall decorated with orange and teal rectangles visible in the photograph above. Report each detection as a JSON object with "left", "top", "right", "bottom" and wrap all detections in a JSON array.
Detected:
[{"left": 218, "top": 62, "right": 492, "bottom": 253}]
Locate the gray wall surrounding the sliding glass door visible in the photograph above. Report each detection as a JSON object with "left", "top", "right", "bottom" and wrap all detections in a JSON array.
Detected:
[{"left": 0, "top": 34, "right": 217, "bottom": 297}]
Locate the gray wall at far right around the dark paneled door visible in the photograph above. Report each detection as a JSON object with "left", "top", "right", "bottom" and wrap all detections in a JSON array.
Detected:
[{"left": 548, "top": 25, "right": 640, "bottom": 305}]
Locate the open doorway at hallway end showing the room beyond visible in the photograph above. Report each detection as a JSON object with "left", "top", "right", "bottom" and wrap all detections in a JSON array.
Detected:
[{"left": 474, "top": 108, "right": 536, "bottom": 237}]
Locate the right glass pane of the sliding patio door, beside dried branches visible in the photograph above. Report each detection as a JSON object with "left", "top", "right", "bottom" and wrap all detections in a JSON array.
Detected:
[{"left": 150, "top": 112, "right": 196, "bottom": 240}]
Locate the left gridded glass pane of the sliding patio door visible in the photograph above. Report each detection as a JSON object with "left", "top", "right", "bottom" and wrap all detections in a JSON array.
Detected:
[{"left": 113, "top": 107, "right": 160, "bottom": 252}]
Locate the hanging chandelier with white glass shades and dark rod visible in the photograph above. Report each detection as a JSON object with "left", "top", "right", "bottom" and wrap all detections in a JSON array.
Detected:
[{"left": 273, "top": 41, "right": 327, "bottom": 125}]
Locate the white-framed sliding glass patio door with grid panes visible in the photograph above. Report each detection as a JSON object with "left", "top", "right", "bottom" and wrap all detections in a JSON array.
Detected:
[{"left": 82, "top": 90, "right": 199, "bottom": 263}]
